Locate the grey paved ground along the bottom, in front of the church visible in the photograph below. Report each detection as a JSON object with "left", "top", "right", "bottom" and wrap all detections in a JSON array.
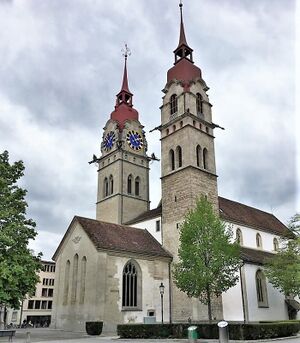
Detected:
[{"left": 0, "top": 329, "right": 300, "bottom": 343}]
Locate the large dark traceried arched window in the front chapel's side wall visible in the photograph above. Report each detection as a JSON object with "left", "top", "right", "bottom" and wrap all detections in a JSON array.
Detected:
[{"left": 122, "top": 261, "right": 142, "bottom": 309}]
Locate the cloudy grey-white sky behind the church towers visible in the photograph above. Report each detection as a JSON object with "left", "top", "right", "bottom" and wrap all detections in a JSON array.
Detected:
[{"left": 0, "top": 0, "right": 300, "bottom": 259}]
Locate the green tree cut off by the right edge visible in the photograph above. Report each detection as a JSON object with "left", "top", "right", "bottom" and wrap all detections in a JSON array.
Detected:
[{"left": 266, "top": 214, "right": 300, "bottom": 296}]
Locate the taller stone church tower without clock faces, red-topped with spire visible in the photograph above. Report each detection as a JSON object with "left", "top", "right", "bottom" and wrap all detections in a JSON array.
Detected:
[{"left": 160, "top": 3, "right": 221, "bottom": 321}]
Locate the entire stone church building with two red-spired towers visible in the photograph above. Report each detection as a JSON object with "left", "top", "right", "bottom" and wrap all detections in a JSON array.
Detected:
[{"left": 52, "top": 4, "right": 296, "bottom": 331}]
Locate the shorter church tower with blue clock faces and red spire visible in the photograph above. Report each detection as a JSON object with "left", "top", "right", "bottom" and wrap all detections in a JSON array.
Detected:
[{"left": 96, "top": 46, "right": 149, "bottom": 224}]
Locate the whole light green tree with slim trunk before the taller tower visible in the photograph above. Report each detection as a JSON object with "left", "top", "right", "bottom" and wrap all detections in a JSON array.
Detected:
[{"left": 173, "top": 197, "right": 241, "bottom": 321}]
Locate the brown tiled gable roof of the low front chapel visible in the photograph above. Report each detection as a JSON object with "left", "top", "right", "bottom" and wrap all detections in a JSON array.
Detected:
[{"left": 53, "top": 216, "right": 172, "bottom": 259}]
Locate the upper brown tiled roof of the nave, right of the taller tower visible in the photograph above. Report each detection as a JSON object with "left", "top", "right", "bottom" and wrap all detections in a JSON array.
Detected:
[{"left": 219, "top": 196, "right": 291, "bottom": 235}]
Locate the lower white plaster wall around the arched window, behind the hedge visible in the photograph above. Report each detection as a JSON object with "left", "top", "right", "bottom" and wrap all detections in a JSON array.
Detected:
[{"left": 245, "top": 264, "right": 288, "bottom": 321}]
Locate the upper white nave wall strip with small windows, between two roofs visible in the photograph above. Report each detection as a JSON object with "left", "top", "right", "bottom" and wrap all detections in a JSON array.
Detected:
[{"left": 227, "top": 223, "right": 280, "bottom": 252}]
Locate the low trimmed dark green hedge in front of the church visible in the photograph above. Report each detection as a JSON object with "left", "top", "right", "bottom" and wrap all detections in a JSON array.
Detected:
[{"left": 117, "top": 322, "right": 300, "bottom": 340}]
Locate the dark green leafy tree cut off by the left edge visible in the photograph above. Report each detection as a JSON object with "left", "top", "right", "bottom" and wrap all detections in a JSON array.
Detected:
[{"left": 0, "top": 151, "right": 41, "bottom": 326}]
